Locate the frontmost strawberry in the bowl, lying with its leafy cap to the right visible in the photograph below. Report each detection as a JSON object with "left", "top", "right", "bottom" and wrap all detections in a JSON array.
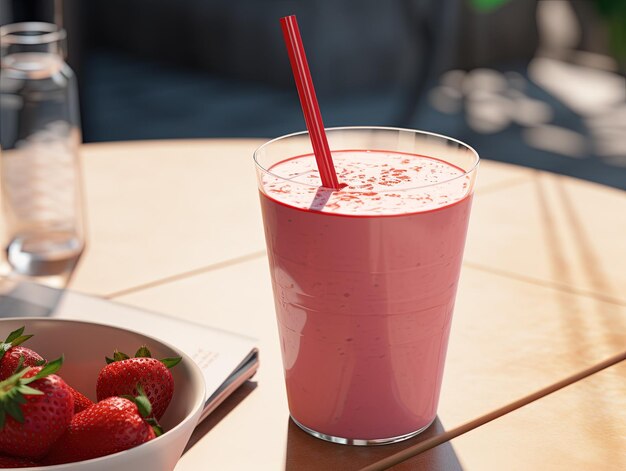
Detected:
[{"left": 44, "top": 386, "right": 163, "bottom": 465}]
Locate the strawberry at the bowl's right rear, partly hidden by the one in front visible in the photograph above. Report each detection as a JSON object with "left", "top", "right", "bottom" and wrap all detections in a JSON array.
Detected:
[{"left": 96, "top": 346, "right": 181, "bottom": 419}]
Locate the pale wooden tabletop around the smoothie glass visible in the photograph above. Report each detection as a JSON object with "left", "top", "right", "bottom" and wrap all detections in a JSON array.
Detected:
[{"left": 70, "top": 139, "right": 626, "bottom": 471}]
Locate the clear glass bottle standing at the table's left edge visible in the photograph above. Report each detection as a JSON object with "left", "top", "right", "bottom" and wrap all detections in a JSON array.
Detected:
[{"left": 0, "top": 22, "right": 85, "bottom": 287}]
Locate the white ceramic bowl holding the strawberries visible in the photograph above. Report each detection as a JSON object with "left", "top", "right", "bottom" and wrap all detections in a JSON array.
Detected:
[{"left": 0, "top": 317, "right": 205, "bottom": 471}]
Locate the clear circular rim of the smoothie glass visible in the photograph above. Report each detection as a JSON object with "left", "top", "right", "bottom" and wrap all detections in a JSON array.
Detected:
[{"left": 253, "top": 126, "right": 480, "bottom": 193}]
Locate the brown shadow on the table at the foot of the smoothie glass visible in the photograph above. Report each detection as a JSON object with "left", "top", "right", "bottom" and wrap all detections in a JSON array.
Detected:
[{"left": 285, "top": 418, "right": 463, "bottom": 471}]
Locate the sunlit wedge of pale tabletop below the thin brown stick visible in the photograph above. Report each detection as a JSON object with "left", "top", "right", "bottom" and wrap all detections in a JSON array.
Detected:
[{"left": 396, "top": 362, "right": 626, "bottom": 471}]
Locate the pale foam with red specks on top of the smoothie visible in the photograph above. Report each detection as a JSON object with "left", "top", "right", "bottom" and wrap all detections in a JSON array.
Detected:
[{"left": 263, "top": 150, "right": 470, "bottom": 215}]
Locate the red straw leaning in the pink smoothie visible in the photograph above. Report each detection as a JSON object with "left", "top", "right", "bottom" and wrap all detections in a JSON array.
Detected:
[{"left": 280, "top": 15, "right": 340, "bottom": 190}]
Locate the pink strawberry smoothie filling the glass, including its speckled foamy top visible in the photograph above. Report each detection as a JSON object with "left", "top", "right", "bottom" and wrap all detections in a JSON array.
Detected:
[{"left": 261, "top": 150, "right": 472, "bottom": 440}]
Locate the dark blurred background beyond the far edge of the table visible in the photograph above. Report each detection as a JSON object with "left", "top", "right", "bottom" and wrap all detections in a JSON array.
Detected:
[{"left": 0, "top": 0, "right": 626, "bottom": 189}]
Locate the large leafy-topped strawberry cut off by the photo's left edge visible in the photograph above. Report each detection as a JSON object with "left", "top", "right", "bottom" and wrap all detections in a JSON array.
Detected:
[{"left": 0, "top": 358, "right": 74, "bottom": 459}]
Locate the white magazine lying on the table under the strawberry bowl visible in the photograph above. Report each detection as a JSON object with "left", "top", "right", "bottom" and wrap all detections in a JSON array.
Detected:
[{"left": 0, "top": 283, "right": 258, "bottom": 418}]
